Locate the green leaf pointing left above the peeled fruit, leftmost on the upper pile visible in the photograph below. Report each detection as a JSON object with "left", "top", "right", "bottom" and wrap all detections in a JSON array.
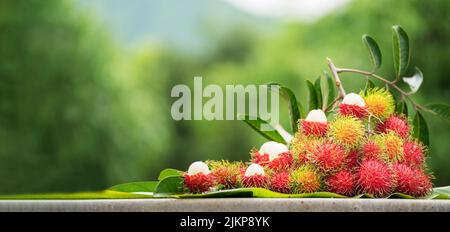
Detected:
[{"left": 238, "top": 115, "right": 286, "bottom": 144}]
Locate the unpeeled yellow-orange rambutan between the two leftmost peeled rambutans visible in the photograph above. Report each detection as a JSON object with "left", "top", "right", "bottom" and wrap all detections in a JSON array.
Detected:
[{"left": 207, "top": 160, "right": 244, "bottom": 189}]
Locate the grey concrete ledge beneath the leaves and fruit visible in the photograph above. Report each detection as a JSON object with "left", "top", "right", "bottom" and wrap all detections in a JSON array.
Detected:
[{"left": 0, "top": 198, "right": 450, "bottom": 212}]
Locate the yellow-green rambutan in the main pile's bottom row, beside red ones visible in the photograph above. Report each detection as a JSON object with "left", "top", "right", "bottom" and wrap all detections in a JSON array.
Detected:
[{"left": 289, "top": 165, "right": 322, "bottom": 193}]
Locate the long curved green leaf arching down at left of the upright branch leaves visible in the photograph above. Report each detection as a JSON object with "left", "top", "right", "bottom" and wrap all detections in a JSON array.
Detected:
[{"left": 267, "top": 83, "right": 303, "bottom": 133}]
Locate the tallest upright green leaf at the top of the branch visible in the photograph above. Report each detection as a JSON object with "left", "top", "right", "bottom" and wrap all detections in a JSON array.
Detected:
[{"left": 392, "top": 25, "right": 410, "bottom": 78}]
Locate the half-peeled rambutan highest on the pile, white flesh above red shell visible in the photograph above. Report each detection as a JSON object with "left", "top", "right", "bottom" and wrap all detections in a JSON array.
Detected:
[{"left": 338, "top": 93, "right": 367, "bottom": 119}]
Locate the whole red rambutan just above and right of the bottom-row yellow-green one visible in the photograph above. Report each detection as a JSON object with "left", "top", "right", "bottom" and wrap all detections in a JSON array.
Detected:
[{"left": 310, "top": 141, "right": 347, "bottom": 172}]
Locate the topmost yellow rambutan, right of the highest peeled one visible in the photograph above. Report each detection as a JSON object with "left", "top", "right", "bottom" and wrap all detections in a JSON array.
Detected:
[{"left": 361, "top": 88, "right": 395, "bottom": 119}]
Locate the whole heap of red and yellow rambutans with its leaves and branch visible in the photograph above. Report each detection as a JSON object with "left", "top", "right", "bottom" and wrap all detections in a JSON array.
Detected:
[{"left": 113, "top": 26, "right": 450, "bottom": 199}]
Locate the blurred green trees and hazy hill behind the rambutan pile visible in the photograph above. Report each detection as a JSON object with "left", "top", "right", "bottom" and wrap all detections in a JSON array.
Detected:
[{"left": 0, "top": 0, "right": 450, "bottom": 194}]
